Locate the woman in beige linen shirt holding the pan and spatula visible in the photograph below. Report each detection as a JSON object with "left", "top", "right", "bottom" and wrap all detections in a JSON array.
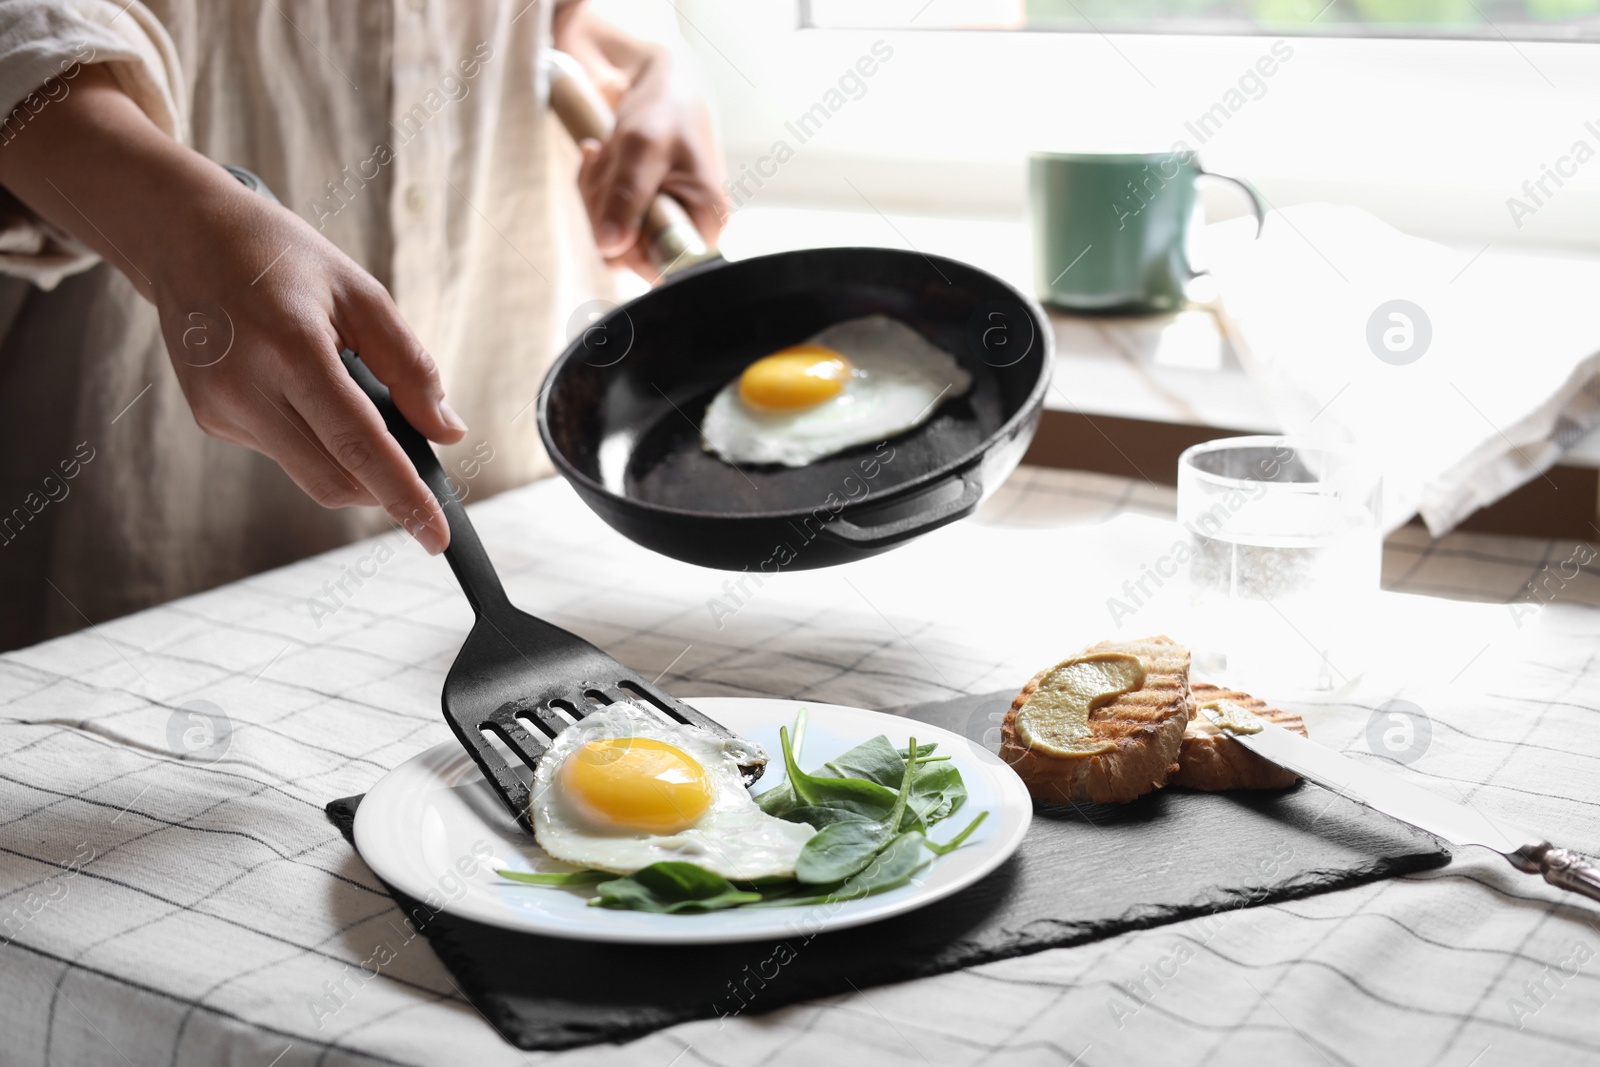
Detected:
[{"left": 0, "top": 0, "right": 722, "bottom": 648}]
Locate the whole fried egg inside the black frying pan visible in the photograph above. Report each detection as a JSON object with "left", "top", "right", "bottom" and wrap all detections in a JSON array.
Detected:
[{"left": 701, "top": 315, "right": 973, "bottom": 467}]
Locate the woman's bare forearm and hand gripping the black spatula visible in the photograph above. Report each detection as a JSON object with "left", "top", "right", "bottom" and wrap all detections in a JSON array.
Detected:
[{"left": 0, "top": 67, "right": 466, "bottom": 552}]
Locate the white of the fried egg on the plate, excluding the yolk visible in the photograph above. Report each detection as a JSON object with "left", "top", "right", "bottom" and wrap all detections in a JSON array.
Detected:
[{"left": 530, "top": 702, "right": 816, "bottom": 881}]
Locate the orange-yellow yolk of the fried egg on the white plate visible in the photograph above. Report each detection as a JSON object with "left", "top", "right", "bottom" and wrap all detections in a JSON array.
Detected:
[{"left": 562, "top": 737, "right": 715, "bottom": 833}]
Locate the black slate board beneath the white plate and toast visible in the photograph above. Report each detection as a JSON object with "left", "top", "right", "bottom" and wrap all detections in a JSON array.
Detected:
[{"left": 326, "top": 693, "right": 1450, "bottom": 1049}]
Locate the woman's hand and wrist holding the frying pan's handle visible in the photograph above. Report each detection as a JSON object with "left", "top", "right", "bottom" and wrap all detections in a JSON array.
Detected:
[{"left": 557, "top": 3, "right": 728, "bottom": 280}]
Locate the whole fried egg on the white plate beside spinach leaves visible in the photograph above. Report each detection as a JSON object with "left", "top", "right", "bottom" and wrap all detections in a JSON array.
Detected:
[{"left": 530, "top": 702, "right": 816, "bottom": 881}]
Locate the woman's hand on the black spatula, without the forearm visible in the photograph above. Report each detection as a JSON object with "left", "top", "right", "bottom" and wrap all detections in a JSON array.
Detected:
[{"left": 150, "top": 173, "right": 467, "bottom": 552}]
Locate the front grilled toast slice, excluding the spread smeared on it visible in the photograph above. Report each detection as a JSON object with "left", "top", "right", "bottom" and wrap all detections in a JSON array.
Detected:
[{"left": 1000, "top": 637, "right": 1192, "bottom": 803}]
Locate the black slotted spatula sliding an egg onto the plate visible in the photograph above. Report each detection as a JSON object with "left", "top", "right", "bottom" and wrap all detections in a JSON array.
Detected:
[{"left": 342, "top": 350, "right": 765, "bottom": 827}]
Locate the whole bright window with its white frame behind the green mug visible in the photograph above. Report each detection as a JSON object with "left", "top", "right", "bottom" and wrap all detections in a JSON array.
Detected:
[{"left": 674, "top": 0, "right": 1600, "bottom": 251}]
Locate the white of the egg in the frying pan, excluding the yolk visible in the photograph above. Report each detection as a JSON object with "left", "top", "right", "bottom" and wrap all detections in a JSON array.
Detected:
[{"left": 701, "top": 315, "right": 973, "bottom": 467}]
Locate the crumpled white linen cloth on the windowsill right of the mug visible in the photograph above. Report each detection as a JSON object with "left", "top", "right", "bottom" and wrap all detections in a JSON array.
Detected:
[{"left": 1206, "top": 203, "right": 1600, "bottom": 536}]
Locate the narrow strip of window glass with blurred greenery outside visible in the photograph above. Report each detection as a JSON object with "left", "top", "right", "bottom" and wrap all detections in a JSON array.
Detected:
[{"left": 802, "top": 0, "right": 1600, "bottom": 42}]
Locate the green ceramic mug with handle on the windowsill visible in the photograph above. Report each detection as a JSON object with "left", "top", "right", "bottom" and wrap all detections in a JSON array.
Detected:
[{"left": 1027, "top": 150, "right": 1266, "bottom": 312}]
